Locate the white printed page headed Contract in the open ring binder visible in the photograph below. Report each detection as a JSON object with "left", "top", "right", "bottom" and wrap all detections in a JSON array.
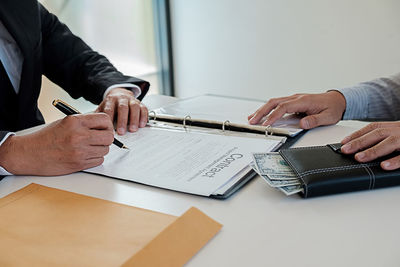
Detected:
[{"left": 86, "top": 126, "right": 280, "bottom": 196}]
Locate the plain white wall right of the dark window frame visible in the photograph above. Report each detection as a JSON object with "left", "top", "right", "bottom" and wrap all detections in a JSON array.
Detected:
[{"left": 171, "top": 0, "right": 400, "bottom": 99}]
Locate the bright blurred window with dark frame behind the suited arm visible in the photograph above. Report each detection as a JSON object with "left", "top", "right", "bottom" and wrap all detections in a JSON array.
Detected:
[{"left": 39, "top": 0, "right": 173, "bottom": 122}]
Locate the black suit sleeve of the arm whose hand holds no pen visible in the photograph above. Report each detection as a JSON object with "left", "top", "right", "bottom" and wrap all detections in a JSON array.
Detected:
[{"left": 39, "top": 5, "right": 150, "bottom": 104}]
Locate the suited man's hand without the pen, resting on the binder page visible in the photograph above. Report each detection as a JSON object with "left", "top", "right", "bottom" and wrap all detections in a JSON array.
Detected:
[{"left": 96, "top": 88, "right": 148, "bottom": 135}]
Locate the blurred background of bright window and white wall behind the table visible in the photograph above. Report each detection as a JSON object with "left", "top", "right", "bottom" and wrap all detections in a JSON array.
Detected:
[{"left": 40, "top": 0, "right": 400, "bottom": 121}]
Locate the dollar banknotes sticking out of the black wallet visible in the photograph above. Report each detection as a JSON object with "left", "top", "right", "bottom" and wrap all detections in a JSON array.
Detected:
[{"left": 250, "top": 152, "right": 303, "bottom": 196}]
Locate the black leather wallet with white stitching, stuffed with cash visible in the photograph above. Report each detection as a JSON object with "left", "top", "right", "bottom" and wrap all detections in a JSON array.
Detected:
[{"left": 279, "top": 144, "right": 400, "bottom": 198}]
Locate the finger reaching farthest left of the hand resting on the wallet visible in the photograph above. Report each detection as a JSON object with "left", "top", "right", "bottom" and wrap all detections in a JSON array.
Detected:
[{"left": 341, "top": 128, "right": 393, "bottom": 154}]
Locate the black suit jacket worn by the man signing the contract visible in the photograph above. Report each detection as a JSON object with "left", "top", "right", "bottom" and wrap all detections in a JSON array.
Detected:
[{"left": 0, "top": 0, "right": 150, "bottom": 140}]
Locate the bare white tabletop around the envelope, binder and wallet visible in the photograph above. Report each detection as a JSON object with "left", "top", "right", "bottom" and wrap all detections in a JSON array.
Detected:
[{"left": 0, "top": 96, "right": 400, "bottom": 267}]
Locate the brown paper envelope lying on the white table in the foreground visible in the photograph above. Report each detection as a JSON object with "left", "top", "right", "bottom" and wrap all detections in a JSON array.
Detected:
[{"left": 0, "top": 184, "right": 222, "bottom": 266}]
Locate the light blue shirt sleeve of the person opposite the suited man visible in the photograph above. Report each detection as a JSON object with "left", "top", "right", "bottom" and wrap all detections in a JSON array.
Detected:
[{"left": 336, "top": 73, "right": 400, "bottom": 120}]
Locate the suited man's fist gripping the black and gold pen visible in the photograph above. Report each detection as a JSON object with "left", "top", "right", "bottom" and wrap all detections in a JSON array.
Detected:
[{"left": 0, "top": 113, "right": 114, "bottom": 176}]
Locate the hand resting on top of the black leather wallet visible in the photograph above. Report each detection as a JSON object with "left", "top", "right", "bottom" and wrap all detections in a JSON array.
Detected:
[{"left": 342, "top": 122, "right": 400, "bottom": 170}]
